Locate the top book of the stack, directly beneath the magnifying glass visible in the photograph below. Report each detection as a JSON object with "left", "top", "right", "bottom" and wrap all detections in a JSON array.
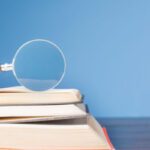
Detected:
[{"left": 0, "top": 86, "right": 82, "bottom": 105}]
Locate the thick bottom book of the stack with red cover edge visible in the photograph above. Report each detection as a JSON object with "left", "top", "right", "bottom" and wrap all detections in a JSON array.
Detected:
[{"left": 0, "top": 115, "right": 113, "bottom": 150}]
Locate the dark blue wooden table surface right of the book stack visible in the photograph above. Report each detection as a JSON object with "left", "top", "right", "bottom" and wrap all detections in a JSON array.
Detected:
[{"left": 97, "top": 118, "right": 150, "bottom": 150}]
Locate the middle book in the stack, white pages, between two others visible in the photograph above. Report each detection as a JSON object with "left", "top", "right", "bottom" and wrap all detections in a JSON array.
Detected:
[{"left": 0, "top": 104, "right": 86, "bottom": 123}]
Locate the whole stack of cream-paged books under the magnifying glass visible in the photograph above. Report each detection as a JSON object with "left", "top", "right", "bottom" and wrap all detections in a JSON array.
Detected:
[{"left": 0, "top": 87, "right": 114, "bottom": 150}]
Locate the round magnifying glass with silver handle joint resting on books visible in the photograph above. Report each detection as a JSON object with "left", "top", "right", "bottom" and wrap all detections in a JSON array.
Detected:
[{"left": 0, "top": 39, "right": 66, "bottom": 91}]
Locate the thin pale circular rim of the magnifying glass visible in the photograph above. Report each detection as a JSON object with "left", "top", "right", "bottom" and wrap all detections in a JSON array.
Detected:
[{"left": 12, "top": 39, "right": 66, "bottom": 92}]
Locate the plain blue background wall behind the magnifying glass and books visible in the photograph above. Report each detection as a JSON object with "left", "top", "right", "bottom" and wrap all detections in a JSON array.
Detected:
[{"left": 0, "top": 0, "right": 150, "bottom": 117}]
